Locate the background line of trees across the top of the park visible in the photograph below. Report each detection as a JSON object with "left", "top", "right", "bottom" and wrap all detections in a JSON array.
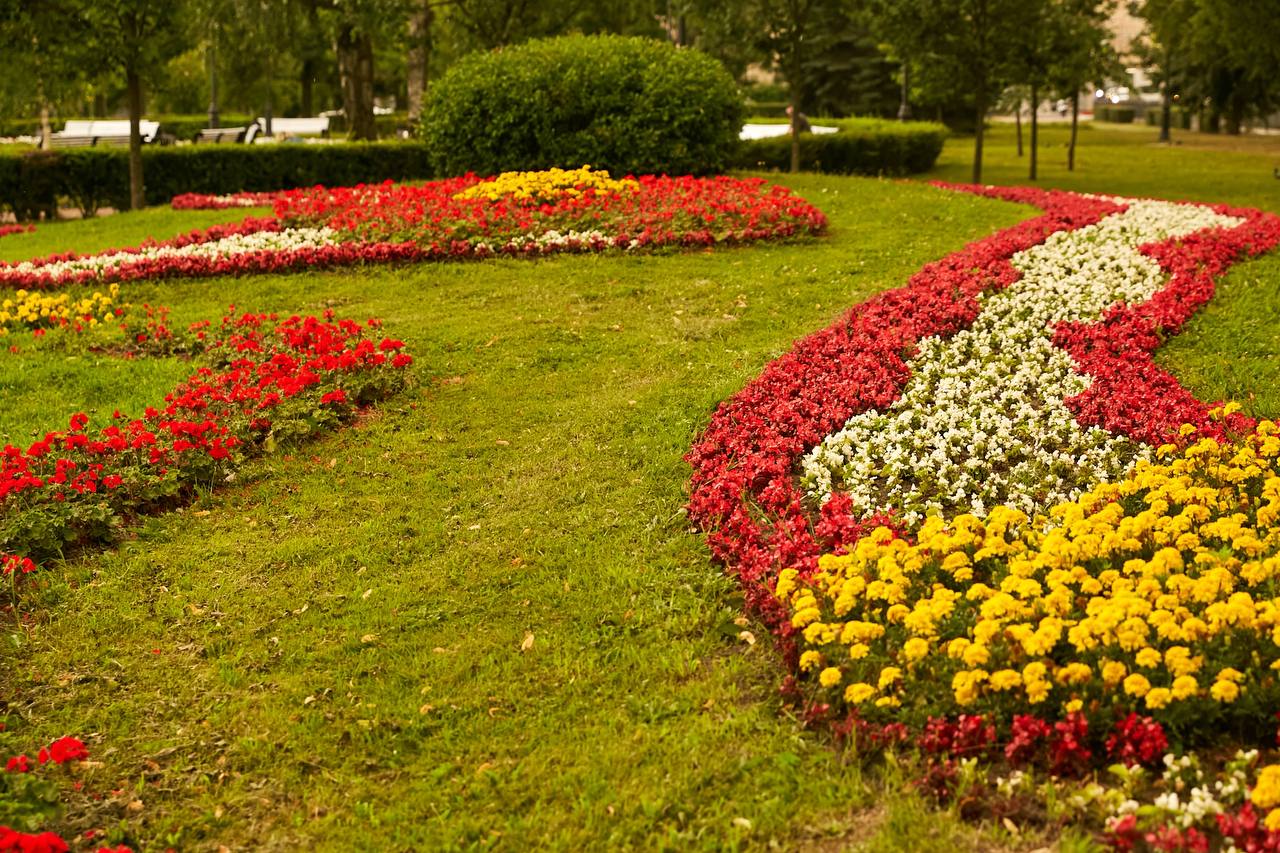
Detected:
[{"left": 0, "top": 0, "right": 1280, "bottom": 204}]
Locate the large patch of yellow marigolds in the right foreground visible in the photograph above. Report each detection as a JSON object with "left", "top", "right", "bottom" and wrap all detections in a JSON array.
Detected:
[{"left": 776, "top": 409, "right": 1280, "bottom": 722}]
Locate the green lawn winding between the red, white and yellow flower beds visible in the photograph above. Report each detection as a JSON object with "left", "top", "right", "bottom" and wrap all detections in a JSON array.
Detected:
[{"left": 0, "top": 133, "right": 1280, "bottom": 850}]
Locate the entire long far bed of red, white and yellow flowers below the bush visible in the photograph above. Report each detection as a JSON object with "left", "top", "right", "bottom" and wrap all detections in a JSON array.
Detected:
[{"left": 0, "top": 169, "right": 827, "bottom": 289}]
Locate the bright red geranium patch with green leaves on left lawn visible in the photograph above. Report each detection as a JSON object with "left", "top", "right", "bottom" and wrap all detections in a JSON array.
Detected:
[{"left": 0, "top": 313, "right": 412, "bottom": 563}]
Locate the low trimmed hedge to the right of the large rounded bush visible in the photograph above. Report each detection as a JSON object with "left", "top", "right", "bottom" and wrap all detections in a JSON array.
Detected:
[{"left": 735, "top": 119, "right": 947, "bottom": 175}]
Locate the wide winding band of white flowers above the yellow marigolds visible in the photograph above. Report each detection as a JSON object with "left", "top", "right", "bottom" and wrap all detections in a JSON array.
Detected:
[{"left": 801, "top": 201, "right": 1240, "bottom": 525}]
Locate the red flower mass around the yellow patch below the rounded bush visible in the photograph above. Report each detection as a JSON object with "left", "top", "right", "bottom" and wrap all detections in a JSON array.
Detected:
[{"left": 275, "top": 174, "right": 827, "bottom": 249}]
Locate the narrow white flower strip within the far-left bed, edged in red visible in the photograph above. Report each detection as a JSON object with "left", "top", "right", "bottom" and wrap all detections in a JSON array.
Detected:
[{"left": 0, "top": 228, "right": 338, "bottom": 283}]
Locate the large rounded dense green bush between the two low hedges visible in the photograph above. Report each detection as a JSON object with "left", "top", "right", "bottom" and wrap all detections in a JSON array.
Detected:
[{"left": 420, "top": 36, "right": 742, "bottom": 175}]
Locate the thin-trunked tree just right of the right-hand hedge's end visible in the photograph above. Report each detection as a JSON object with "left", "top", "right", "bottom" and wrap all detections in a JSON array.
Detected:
[{"left": 869, "top": 0, "right": 1036, "bottom": 183}]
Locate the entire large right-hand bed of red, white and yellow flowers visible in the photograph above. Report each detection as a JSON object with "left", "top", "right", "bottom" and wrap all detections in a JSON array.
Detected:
[{"left": 689, "top": 188, "right": 1280, "bottom": 845}]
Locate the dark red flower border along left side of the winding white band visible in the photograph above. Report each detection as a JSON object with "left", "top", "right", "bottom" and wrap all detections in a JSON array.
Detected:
[{"left": 686, "top": 188, "right": 1120, "bottom": 640}]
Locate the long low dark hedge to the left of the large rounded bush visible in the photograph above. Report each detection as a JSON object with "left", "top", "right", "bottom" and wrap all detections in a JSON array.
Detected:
[{"left": 0, "top": 142, "right": 431, "bottom": 220}]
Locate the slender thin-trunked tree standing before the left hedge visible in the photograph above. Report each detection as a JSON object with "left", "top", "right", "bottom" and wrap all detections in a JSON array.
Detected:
[{"left": 77, "top": 0, "right": 187, "bottom": 210}]
